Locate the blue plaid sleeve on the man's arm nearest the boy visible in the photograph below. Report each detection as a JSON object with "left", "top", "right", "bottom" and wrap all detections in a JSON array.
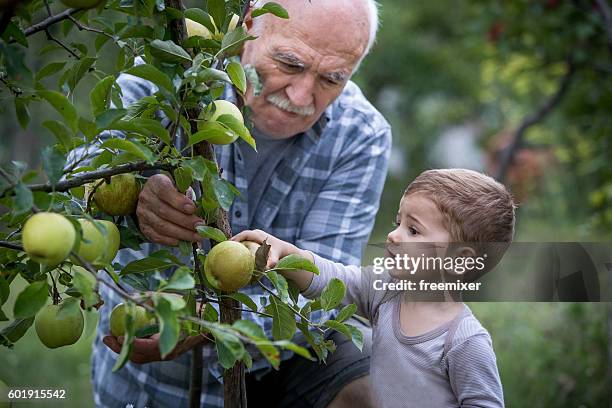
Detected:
[{"left": 295, "top": 126, "right": 391, "bottom": 265}]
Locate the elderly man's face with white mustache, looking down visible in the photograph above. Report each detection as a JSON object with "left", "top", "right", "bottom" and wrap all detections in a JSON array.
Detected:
[{"left": 242, "top": 2, "right": 368, "bottom": 138}]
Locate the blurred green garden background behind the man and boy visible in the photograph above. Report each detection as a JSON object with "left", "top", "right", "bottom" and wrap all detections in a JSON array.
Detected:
[{"left": 0, "top": 0, "right": 612, "bottom": 407}]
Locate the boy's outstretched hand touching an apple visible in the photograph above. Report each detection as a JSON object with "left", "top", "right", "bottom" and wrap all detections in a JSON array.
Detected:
[{"left": 231, "top": 230, "right": 314, "bottom": 291}]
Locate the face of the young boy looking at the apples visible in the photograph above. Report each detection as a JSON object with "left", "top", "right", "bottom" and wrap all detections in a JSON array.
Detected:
[{"left": 386, "top": 193, "right": 451, "bottom": 278}]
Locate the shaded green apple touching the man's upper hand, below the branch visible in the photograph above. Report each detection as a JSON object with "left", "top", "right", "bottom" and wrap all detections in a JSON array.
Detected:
[{"left": 93, "top": 173, "right": 140, "bottom": 215}]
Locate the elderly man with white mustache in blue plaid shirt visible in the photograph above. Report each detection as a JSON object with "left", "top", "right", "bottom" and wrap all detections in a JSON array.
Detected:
[{"left": 92, "top": 0, "right": 391, "bottom": 407}]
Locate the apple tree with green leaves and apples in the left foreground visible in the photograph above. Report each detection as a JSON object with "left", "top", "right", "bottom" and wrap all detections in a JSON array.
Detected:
[{"left": 0, "top": 0, "right": 362, "bottom": 407}]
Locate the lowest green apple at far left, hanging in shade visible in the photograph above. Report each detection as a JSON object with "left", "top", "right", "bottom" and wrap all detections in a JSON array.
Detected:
[{"left": 34, "top": 299, "right": 85, "bottom": 348}]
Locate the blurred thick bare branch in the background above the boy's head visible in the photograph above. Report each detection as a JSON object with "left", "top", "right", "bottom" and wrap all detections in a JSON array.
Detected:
[{"left": 496, "top": 57, "right": 575, "bottom": 183}]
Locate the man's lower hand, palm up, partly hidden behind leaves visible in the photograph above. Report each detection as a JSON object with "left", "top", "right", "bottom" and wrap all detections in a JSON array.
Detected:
[{"left": 102, "top": 334, "right": 206, "bottom": 364}]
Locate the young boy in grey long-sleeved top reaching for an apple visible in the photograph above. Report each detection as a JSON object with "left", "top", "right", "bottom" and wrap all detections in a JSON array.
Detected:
[{"left": 233, "top": 169, "right": 515, "bottom": 408}]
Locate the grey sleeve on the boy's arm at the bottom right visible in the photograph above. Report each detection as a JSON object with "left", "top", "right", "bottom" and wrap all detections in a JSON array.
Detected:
[{"left": 447, "top": 335, "right": 504, "bottom": 408}]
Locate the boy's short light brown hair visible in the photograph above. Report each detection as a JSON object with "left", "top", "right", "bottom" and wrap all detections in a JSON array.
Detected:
[{"left": 404, "top": 169, "right": 516, "bottom": 278}]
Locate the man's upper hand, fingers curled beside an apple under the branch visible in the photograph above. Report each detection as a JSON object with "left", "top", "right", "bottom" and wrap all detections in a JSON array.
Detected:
[{"left": 136, "top": 174, "right": 204, "bottom": 246}]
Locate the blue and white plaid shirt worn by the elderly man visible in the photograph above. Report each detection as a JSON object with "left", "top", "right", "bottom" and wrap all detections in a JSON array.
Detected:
[{"left": 92, "top": 71, "right": 391, "bottom": 408}]
